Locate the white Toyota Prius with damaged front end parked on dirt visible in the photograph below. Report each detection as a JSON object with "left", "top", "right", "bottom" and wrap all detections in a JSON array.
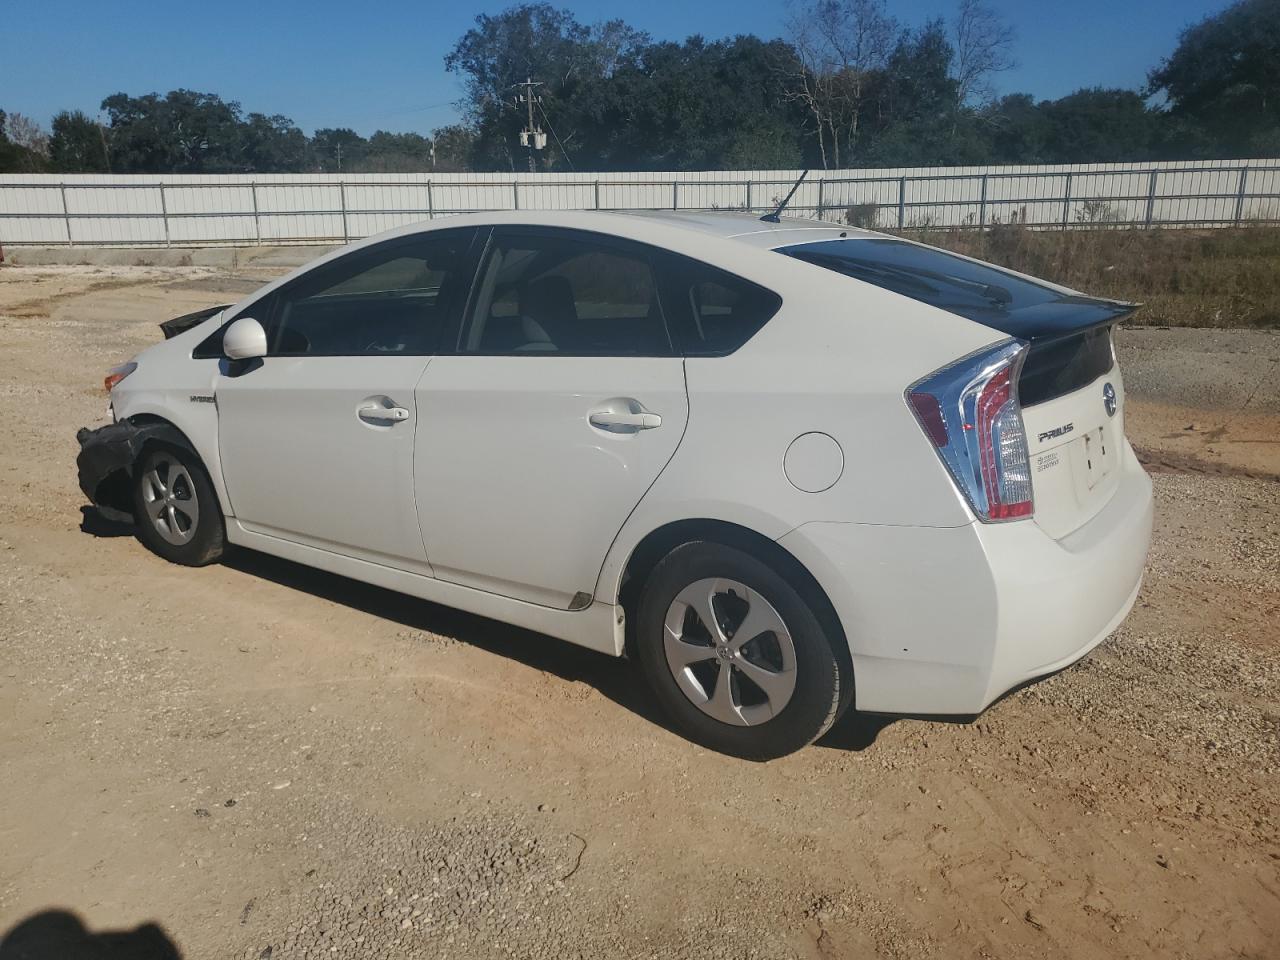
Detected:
[{"left": 78, "top": 211, "right": 1152, "bottom": 759}]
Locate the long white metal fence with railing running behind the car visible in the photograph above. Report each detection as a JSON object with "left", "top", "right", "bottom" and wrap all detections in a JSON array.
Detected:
[{"left": 0, "top": 160, "right": 1280, "bottom": 246}]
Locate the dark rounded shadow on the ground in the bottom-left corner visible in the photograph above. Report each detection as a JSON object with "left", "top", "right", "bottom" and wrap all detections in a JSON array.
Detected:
[{"left": 0, "top": 910, "right": 182, "bottom": 960}]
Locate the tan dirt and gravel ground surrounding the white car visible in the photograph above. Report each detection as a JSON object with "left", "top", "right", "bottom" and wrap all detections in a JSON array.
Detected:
[{"left": 0, "top": 259, "right": 1280, "bottom": 960}]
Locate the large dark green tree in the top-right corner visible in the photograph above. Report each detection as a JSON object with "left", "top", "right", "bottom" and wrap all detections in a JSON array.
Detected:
[{"left": 1147, "top": 0, "right": 1280, "bottom": 156}]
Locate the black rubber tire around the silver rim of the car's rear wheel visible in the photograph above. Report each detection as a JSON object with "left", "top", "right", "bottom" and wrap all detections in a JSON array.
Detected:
[{"left": 635, "top": 541, "right": 852, "bottom": 760}]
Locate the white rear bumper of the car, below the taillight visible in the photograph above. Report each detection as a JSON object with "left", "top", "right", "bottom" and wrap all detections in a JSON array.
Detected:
[{"left": 780, "top": 444, "right": 1153, "bottom": 716}]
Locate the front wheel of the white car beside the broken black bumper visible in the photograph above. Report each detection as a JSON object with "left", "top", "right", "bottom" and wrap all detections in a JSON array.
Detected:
[{"left": 132, "top": 444, "right": 227, "bottom": 567}]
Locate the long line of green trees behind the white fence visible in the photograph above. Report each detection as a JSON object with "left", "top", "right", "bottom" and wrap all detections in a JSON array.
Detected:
[{"left": 0, "top": 0, "right": 1280, "bottom": 173}]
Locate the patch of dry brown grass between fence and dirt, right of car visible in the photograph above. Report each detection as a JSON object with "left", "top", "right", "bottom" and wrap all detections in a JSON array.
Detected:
[{"left": 913, "top": 224, "right": 1280, "bottom": 329}]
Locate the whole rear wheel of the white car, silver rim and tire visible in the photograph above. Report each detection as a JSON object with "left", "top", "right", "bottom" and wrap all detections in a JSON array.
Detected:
[{"left": 636, "top": 541, "right": 851, "bottom": 760}]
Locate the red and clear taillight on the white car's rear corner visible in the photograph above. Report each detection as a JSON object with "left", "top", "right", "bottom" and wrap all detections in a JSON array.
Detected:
[{"left": 906, "top": 340, "right": 1034, "bottom": 522}]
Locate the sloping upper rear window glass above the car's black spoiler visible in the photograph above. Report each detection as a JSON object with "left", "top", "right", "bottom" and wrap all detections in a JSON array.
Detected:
[{"left": 778, "top": 238, "right": 1064, "bottom": 328}]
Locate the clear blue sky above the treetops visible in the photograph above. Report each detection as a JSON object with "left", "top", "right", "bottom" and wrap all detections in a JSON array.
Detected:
[{"left": 0, "top": 0, "right": 1226, "bottom": 134}]
